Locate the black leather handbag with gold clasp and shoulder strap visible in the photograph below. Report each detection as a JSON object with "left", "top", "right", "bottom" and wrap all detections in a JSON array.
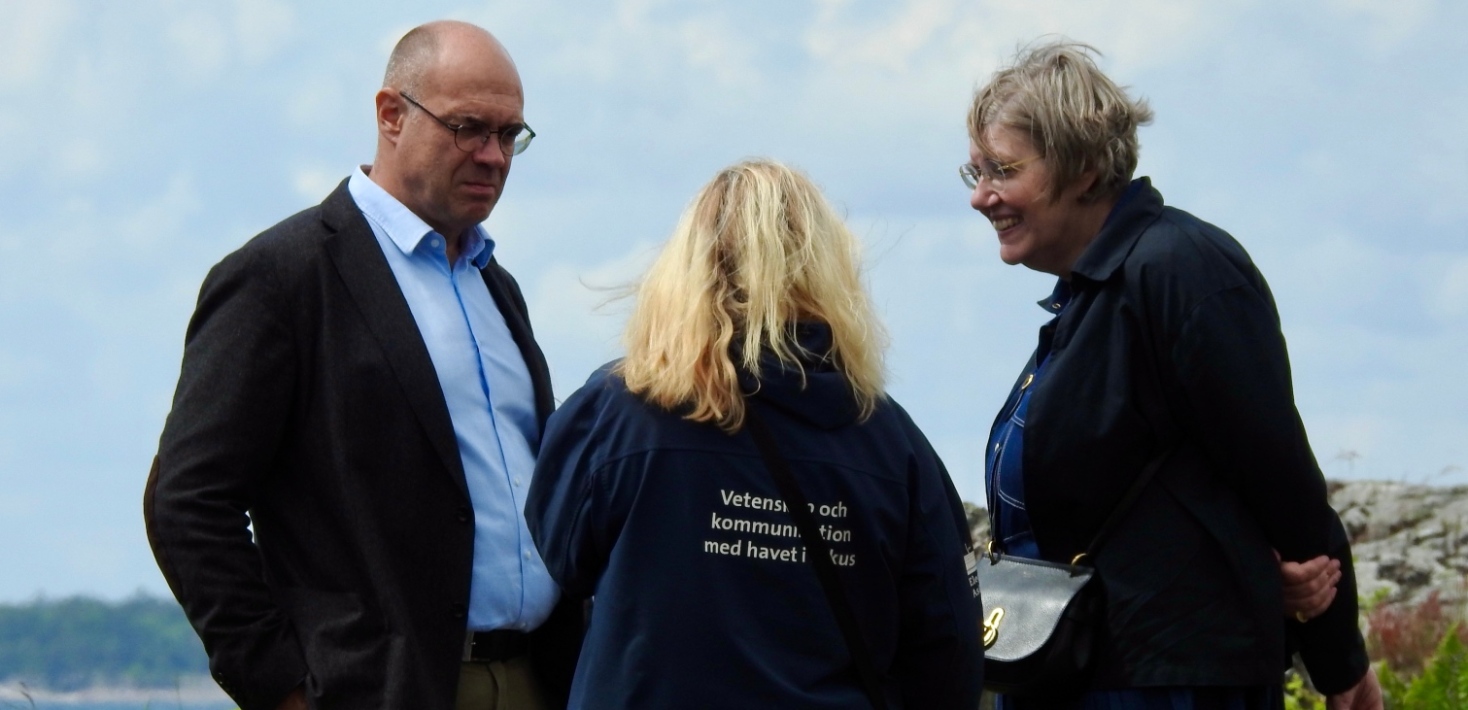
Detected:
[{"left": 976, "top": 449, "right": 1171, "bottom": 697}]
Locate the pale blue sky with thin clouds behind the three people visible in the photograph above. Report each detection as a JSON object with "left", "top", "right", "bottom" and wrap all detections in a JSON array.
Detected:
[{"left": 0, "top": 0, "right": 1468, "bottom": 601}]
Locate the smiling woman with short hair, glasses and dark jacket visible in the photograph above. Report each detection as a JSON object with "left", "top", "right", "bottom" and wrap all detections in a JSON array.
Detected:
[{"left": 960, "top": 41, "right": 1381, "bottom": 710}]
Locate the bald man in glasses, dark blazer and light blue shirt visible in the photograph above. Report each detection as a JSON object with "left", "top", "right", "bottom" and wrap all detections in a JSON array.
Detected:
[{"left": 144, "top": 22, "right": 581, "bottom": 710}]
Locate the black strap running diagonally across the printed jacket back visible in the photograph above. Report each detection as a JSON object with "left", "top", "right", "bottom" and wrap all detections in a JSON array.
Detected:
[{"left": 744, "top": 400, "right": 887, "bottom": 710}]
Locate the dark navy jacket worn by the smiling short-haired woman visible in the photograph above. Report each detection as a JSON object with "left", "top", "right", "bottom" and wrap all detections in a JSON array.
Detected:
[{"left": 1004, "top": 178, "right": 1367, "bottom": 692}]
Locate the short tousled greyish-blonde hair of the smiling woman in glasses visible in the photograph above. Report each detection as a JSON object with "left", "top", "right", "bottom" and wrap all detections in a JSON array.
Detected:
[{"left": 969, "top": 38, "right": 1152, "bottom": 201}]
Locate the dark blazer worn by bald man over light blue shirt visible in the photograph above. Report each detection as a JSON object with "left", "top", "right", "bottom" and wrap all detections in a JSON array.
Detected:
[{"left": 144, "top": 182, "right": 581, "bottom": 710}]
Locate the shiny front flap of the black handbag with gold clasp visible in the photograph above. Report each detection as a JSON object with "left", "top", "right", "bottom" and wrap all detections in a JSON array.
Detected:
[{"left": 979, "top": 555, "right": 1095, "bottom": 662}]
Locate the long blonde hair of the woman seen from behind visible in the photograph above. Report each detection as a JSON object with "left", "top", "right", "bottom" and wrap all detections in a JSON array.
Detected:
[{"left": 617, "top": 160, "right": 887, "bottom": 433}]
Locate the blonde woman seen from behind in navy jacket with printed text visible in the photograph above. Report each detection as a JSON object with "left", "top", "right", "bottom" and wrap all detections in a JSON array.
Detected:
[{"left": 526, "top": 160, "right": 982, "bottom": 710}]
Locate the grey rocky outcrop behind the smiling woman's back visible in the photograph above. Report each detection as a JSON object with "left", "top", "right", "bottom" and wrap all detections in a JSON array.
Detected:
[{"left": 964, "top": 481, "right": 1468, "bottom": 606}]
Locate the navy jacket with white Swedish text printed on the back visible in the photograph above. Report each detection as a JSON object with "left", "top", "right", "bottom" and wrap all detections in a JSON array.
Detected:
[{"left": 526, "top": 326, "right": 982, "bottom": 710}]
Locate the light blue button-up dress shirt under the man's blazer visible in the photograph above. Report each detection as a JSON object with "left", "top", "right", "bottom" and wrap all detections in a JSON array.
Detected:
[{"left": 346, "top": 170, "right": 561, "bottom": 631}]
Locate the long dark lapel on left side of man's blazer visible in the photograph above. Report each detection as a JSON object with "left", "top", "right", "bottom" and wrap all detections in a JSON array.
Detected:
[{"left": 321, "top": 180, "right": 468, "bottom": 497}]
